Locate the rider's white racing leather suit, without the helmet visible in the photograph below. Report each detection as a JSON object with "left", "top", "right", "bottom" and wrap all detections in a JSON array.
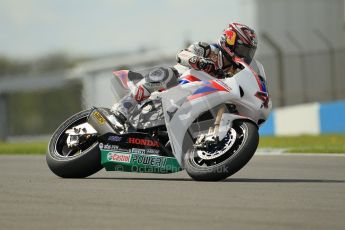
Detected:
[{"left": 112, "top": 42, "right": 235, "bottom": 121}]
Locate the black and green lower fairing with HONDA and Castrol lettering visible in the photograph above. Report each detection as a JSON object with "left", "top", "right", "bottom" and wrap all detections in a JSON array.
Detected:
[{"left": 99, "top": 132, "right": 181, "bottom": 173}]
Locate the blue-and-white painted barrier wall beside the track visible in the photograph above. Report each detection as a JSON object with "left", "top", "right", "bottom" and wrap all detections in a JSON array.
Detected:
[{"left": 260, "top": 100, "right": 345, "bottom": 136}]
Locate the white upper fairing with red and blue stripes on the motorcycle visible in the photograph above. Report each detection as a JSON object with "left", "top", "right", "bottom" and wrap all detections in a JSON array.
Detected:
[{"left": 159, "top": 59, "right": 272, "bottom": 167}]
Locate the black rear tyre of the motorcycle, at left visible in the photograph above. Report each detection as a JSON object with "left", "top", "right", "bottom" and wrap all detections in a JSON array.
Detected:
[{"left": 46, "top": 110, "right": 103, "bottom": 178}]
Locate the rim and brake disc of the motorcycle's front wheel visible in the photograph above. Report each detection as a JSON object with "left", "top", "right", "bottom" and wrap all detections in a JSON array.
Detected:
[{"left": 189, "top": 125, "right": 247, "bottom": 168}]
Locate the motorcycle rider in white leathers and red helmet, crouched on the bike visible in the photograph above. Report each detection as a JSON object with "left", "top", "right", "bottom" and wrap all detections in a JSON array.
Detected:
[{"left": 112, "top": 23, "right": 257, "bottom": 124}]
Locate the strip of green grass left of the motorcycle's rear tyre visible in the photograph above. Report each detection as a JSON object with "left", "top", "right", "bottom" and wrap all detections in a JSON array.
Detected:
[{"left": 0, "top": 142, "right": 48, "bottom": 154}]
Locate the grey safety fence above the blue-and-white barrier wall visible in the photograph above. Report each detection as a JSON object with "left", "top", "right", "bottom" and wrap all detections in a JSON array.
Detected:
[{"left": 258, "top": 44, "right": 345, "bottom": 107}]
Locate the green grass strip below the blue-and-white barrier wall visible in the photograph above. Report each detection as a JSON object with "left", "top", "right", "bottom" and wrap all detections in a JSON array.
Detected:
[{"left": 259, "top": 134, "right": 345, "bottom": 153}]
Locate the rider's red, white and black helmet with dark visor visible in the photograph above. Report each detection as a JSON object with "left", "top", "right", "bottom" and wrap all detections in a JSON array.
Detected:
[{"left": 219, "top": 23, "right": 258, "bottom": 64}]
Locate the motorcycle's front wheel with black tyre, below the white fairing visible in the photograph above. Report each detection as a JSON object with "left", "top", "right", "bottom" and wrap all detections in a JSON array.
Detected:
[{"left": 184, "top": 120, "right": 259, "bottom": 181}]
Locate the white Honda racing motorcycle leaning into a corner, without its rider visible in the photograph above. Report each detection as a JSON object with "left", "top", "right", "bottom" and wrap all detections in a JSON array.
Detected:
[{"left": 46, "top": 59, "right": 272, "bottom": 181}]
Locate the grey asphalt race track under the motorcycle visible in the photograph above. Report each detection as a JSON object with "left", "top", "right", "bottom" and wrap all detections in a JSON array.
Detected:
[{"left": 0, "top": 155, "right": 345, "bottom": 230}]
